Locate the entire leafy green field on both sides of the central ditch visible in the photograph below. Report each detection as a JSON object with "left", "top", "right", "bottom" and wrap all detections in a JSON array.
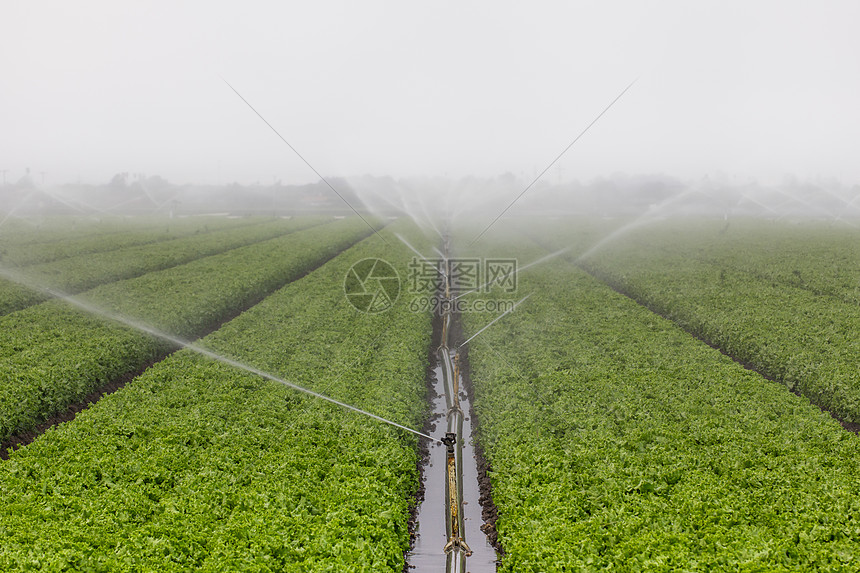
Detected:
[{"left": 0, "top": 212, "right": 860, "bottom": 573}]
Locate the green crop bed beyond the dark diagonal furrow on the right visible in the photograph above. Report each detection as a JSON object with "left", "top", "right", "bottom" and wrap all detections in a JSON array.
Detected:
[{"left": 568, "top": 219, "right": 860, "bottom": 422}]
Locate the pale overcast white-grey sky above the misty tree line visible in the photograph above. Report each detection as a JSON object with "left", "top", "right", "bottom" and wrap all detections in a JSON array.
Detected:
[{"left": 0, "top": 0, "right": 860, "bottom": 184}]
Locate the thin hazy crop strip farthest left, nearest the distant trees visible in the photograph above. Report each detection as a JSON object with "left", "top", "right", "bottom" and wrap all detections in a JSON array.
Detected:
[{"left": 0, "top": 217, "right": 271, "bottom": 266}]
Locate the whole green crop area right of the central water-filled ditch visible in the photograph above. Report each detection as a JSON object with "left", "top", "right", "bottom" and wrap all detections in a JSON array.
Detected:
[{"left": 465, "top": 218, "right": 860, "bottom": 571}]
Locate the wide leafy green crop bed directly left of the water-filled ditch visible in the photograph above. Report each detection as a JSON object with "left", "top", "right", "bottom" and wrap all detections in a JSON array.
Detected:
[{"left": 0, "top": 220, "right": 431, "bottom": 573}]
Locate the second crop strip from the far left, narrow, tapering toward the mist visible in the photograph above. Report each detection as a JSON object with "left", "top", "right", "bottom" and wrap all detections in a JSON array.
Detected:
[{"left": 0, "top": 217, "right": 324, "bottom": 315}]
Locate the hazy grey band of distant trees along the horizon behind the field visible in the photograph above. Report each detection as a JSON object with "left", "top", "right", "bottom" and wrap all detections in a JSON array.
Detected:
[{"left": 0, "top": 173, "right": 860, "bottom": 221}]
